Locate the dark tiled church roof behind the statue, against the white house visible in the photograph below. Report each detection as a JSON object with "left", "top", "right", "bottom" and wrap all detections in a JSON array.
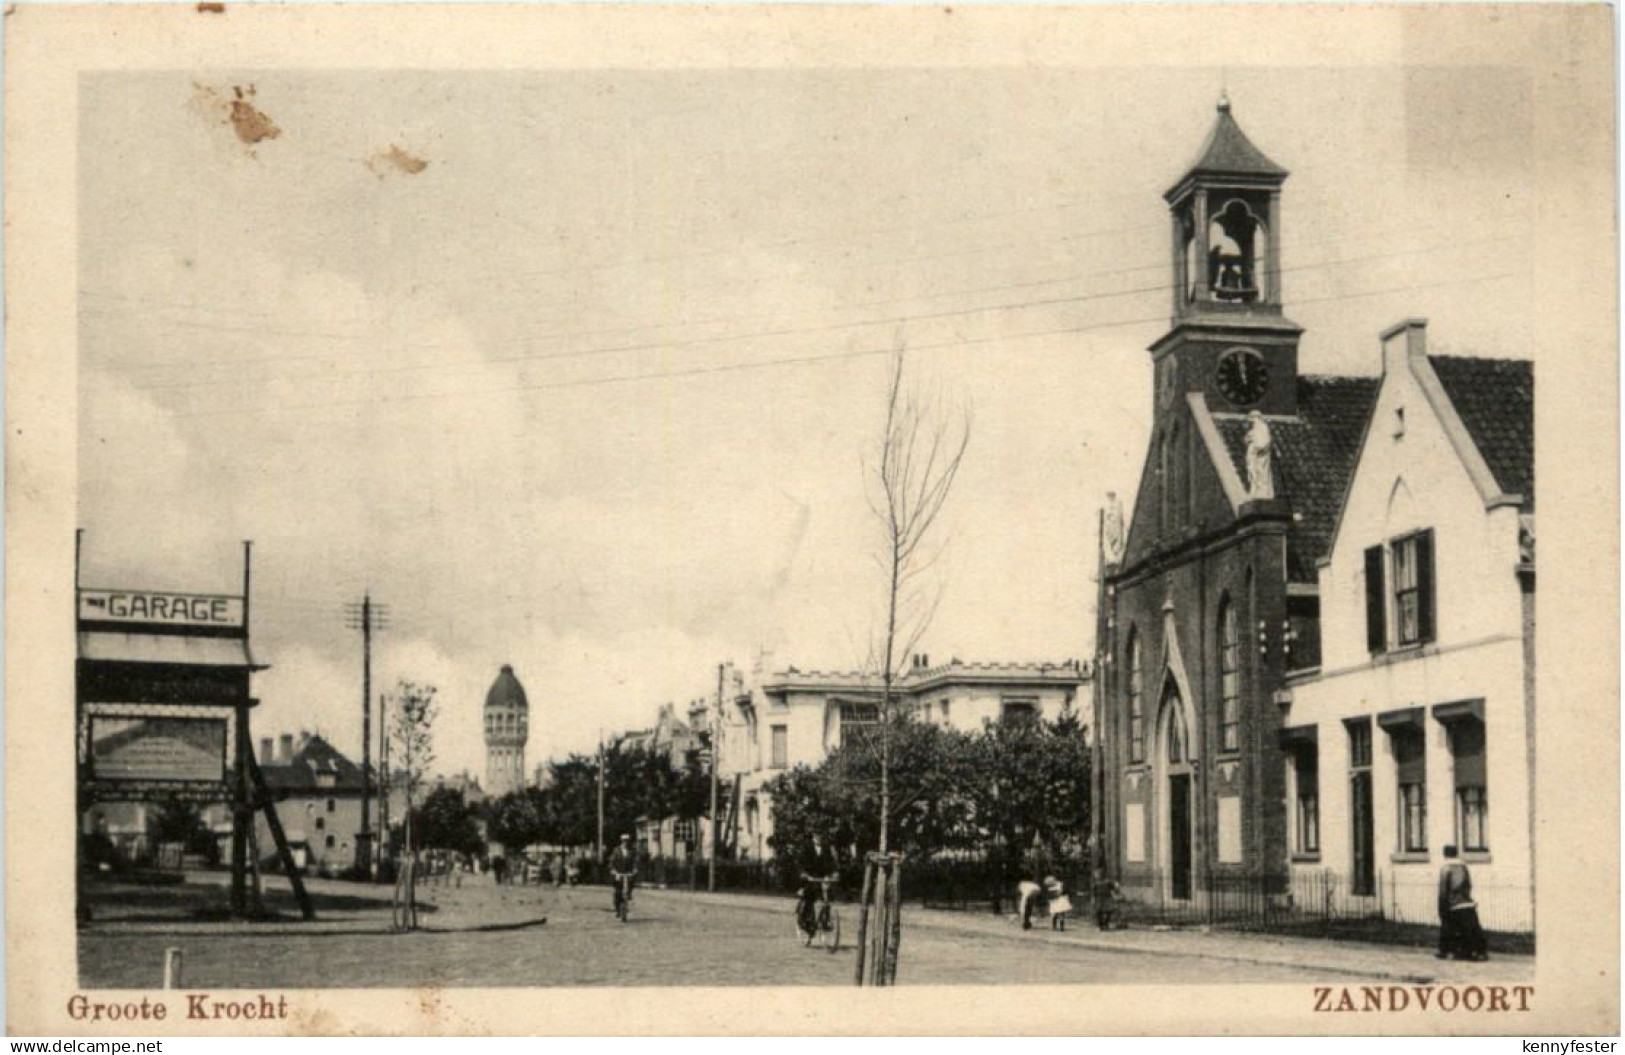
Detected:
[{"left": 1214, "top": 374, "right": 1380, "bottom": 584}]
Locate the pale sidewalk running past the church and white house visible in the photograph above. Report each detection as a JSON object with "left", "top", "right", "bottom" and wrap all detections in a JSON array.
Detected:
[{"left": 640, "top": 888, "right": 1534, "bottom": 985}]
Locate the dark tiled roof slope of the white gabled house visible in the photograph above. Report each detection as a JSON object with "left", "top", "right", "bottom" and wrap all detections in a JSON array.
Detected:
[{"left": 1428, "top": 356, "right": 1534, "bottom": 510}]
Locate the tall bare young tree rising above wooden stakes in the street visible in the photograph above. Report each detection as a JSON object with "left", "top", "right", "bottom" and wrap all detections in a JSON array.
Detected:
[{"left": 869, "top": 333, "right": 970, "bottom": 853}]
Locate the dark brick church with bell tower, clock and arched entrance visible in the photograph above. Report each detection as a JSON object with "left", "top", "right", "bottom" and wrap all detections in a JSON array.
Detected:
[{"left": 1095, "top": 99, "right": 1376, "bottom": 904}]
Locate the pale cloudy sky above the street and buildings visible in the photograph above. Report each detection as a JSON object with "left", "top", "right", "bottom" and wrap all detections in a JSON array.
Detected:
[{"left": 76, "top": 65, "right": 1573, "bottom": 774}]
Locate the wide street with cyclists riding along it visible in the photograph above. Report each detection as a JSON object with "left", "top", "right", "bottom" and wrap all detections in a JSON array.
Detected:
[{"left": 80, "top": 881, "right": 1532, "bottom": 988}]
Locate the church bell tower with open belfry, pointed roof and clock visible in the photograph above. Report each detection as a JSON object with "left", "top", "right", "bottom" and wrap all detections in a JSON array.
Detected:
[{"left": 1151, "top": 94, "right": 1303, "bottom": 415}]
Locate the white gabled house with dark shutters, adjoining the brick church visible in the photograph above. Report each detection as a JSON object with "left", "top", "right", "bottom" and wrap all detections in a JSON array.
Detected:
[{"left": 1277, "top": 320, "right": 1536, "bottom": 931}]
